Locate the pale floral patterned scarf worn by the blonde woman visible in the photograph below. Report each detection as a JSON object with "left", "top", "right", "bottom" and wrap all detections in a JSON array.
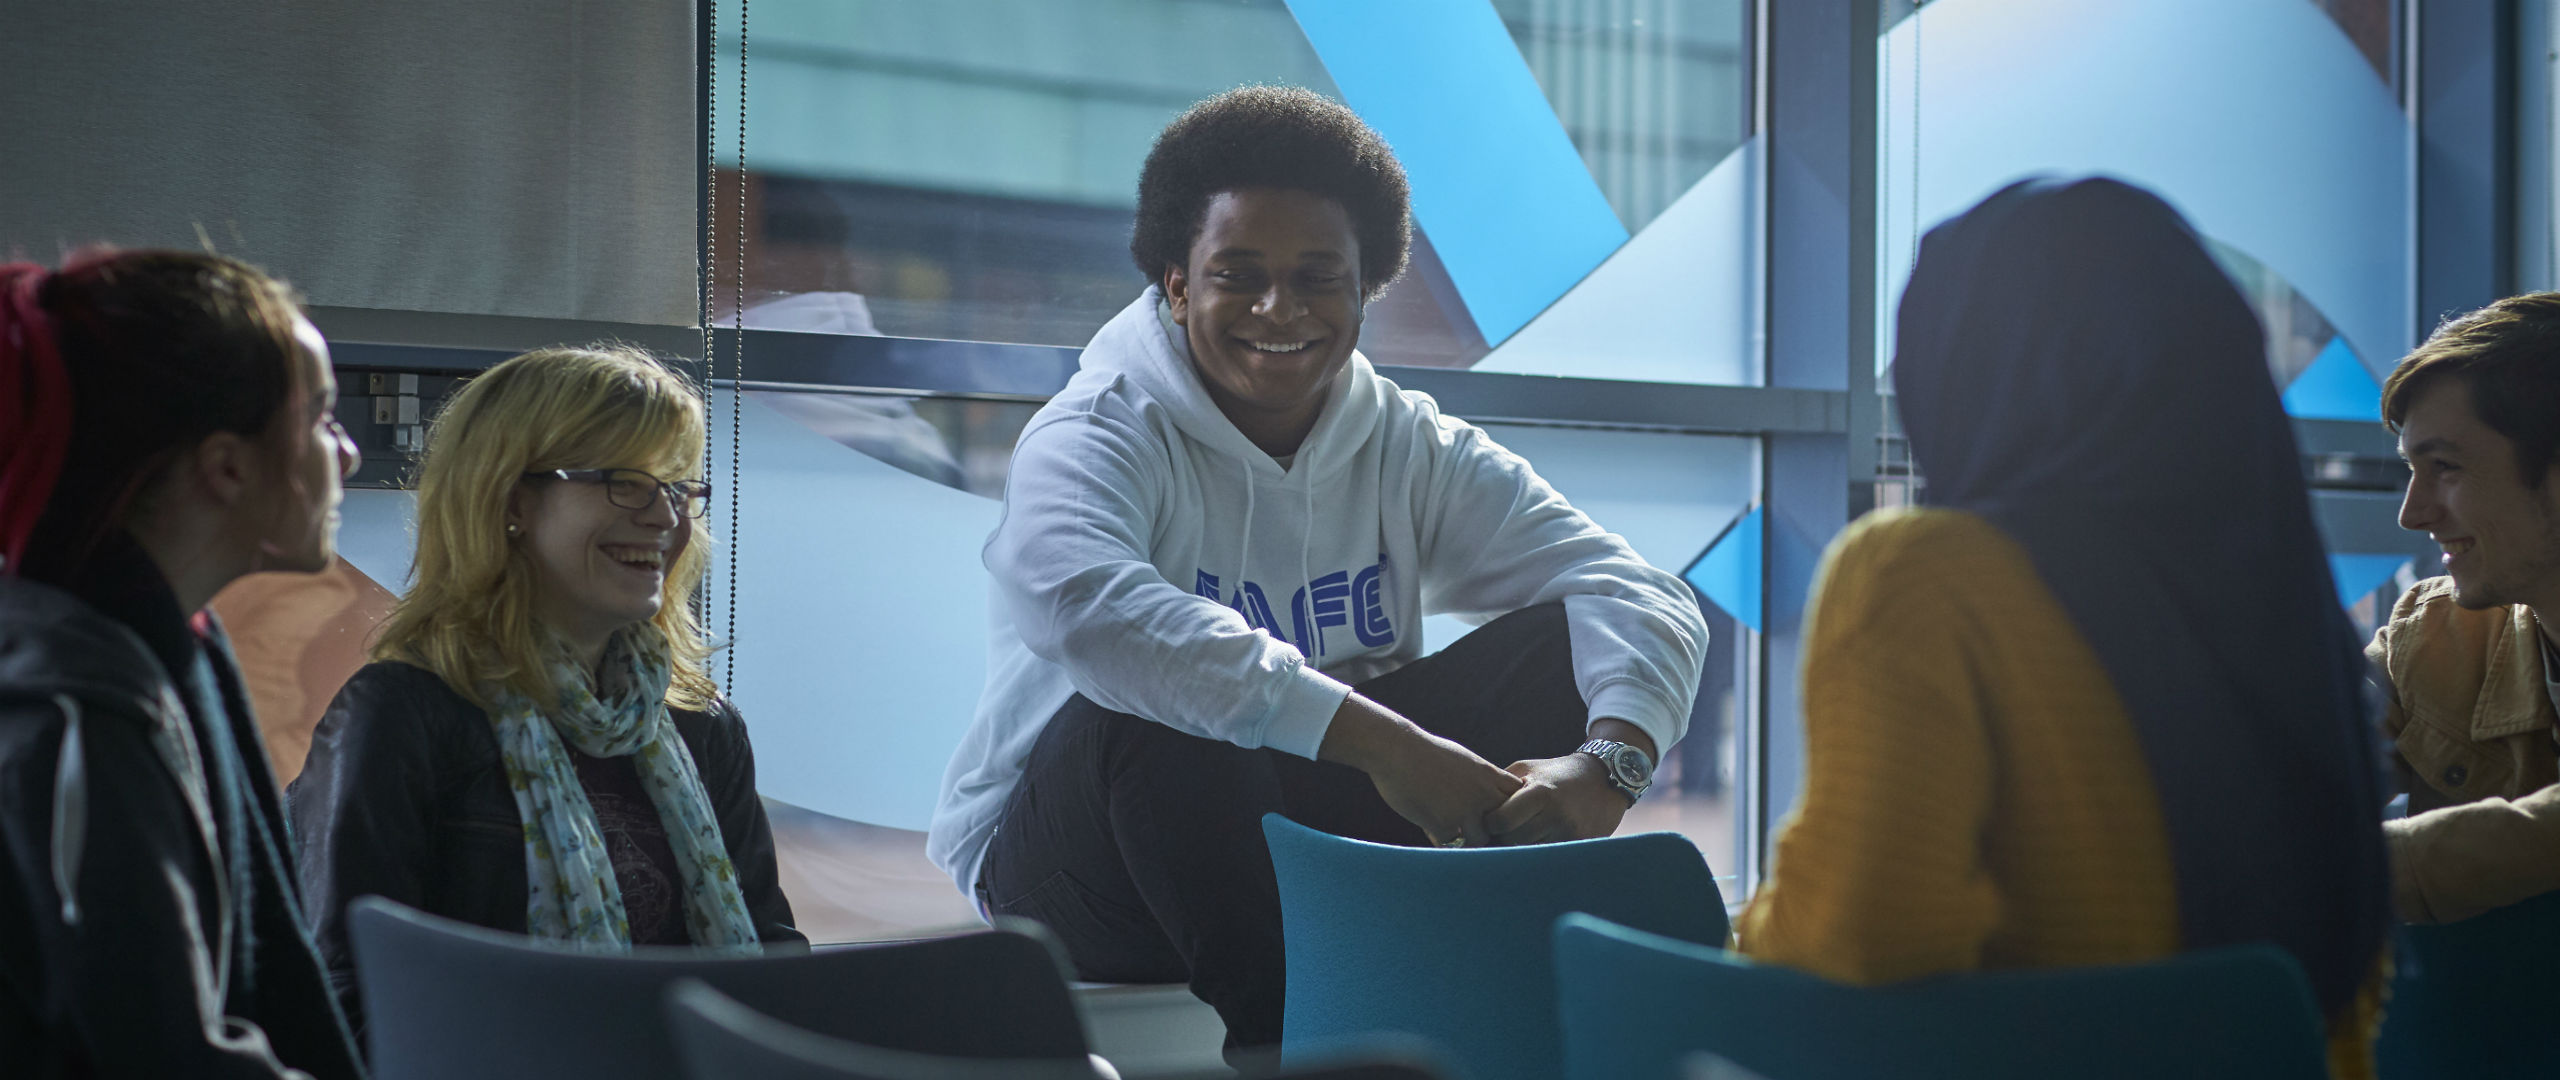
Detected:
[{"left": 489, "top": 627, "right": 758, "bottom": 949}]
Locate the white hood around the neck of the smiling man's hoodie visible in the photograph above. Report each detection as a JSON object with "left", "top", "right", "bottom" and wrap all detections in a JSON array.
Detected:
[{"left": 1080, "top": 284, "right": 1395, "bottom": 484}]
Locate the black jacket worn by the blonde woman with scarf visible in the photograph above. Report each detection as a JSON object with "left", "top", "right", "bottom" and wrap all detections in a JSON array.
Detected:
[{"left": 287, "top": 660, "right": 806, "bottom": 1031}]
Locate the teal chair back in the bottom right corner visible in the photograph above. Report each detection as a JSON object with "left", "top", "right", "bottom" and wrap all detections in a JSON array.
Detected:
[{"left": 2373, "top": 893, "right": 2560, "bottom": 1080}]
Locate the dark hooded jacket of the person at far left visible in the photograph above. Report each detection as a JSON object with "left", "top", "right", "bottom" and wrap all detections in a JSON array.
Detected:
[{"left": 0, "top": 557, "right": 361, "bottom": 1080}]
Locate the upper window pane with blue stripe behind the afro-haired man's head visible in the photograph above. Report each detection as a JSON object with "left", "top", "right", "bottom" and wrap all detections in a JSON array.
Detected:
[{"left": 714, "top": 0, "right": 1759, "bottom": 384}]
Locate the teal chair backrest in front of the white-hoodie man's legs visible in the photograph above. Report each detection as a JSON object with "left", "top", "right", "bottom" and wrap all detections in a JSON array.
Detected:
[{"left": 1262, "top": 814, "right": 1725, "bottom": 1080}]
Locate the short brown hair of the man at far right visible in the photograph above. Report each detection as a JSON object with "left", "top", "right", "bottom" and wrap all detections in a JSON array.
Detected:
[{"left": 2383, "top": 292, "right": 2560, "bottom": 489}]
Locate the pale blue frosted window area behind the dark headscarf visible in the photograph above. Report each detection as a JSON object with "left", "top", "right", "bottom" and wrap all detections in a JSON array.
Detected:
[{"left": 1879, "top": 0, "right": 2412, "bottom": 361}]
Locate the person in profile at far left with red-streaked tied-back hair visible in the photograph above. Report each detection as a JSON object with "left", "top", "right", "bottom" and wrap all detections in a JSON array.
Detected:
[{"left": 0, "top": 251, "right": 364, "bottom": 1077}]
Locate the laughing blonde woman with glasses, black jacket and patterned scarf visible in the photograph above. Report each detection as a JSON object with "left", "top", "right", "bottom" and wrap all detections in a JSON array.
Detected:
[{"left": 292, "top": 348, "right": 804, "bottom": 1039}]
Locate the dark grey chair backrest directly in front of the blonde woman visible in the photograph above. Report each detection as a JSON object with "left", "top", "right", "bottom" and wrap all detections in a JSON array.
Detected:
[{"left": 348, "top": 898, "right": 1085, "bottom": 1080}]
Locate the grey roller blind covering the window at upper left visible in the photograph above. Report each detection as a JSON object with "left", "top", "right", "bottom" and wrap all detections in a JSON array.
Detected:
[{"left": 0, "top": 0, "right": 701, "bottom": 325}]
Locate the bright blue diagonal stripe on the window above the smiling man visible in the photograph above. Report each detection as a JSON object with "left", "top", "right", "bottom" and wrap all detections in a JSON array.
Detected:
[{"left": 1288, "top": 0, "right": 1626, "bottom": 345}]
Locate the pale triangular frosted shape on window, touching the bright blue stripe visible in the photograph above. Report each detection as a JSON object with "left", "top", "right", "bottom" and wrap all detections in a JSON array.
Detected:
[{"left": 1475, "top": 138, "right": 1761, "bottom": 386}]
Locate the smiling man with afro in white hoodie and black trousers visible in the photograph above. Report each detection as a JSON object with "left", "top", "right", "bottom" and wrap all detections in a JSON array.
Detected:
[{"left": 929, "top": 87, "right": 1708, "bottom": 1049}]
